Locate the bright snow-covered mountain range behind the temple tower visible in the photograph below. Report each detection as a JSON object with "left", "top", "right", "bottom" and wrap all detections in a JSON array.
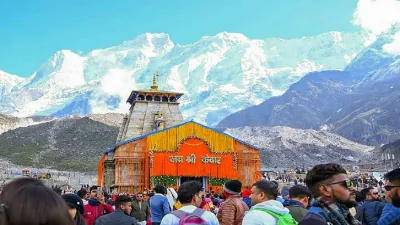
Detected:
[{"left": 0, "top": 32, "right": 367, "bottom": 125}]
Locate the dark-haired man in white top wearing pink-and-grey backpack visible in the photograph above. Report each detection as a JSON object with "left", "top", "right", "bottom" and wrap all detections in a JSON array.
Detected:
[{"left": 161, "top": 181, "right": 219, "bottom": 225}]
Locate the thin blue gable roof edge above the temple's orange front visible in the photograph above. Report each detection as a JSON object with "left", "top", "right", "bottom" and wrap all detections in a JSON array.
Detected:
[{"left": 104, "top": 120, "right": 260, "bottom": 154}]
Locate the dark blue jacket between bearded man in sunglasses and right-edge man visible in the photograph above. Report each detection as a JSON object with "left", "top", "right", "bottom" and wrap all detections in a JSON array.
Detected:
[{"left": 355, "top": 200, "right": 385, "bottom": 225}]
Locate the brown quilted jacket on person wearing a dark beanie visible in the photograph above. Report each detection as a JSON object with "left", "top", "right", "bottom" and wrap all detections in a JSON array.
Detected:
[{"left": 217, "top": 195, "right": 249, "bottom": 225}]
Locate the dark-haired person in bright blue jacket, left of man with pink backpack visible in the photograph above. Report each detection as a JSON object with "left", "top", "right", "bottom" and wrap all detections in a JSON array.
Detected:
[{"left": 150, "top": 185, "right": 171, "bottom": 225}]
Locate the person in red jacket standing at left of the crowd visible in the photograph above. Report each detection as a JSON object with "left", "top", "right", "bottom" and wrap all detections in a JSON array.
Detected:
[{"left": 83, "top": 186, "right": 114, "bottom": 225}]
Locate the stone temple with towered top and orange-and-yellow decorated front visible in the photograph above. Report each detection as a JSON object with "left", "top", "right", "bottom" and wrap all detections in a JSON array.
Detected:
[{"left": 98, "top": 73, "right": 261, "bottom": 193}]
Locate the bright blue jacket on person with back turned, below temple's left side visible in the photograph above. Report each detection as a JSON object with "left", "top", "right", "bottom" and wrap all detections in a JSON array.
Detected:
[{"left": 150, "top": 193, "right": 171, "bottom": 223}]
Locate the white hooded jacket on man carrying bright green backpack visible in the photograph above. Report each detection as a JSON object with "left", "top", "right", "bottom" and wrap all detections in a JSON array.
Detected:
[{"left": 242, "top": 200, "right": 289, "bottom": 225}]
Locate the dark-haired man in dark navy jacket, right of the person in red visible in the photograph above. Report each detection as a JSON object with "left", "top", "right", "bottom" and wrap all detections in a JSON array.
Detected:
[{"left": 95, "top": 195, "right": 138, "bottom": 225}]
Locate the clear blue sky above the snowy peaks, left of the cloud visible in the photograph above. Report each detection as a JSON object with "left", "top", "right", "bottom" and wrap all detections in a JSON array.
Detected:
[{"left": 0, "top": 0, "right": 359, "bottom": 77}]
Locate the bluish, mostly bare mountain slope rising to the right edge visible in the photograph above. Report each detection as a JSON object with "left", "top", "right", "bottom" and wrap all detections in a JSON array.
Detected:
[{"left": 217, "top": 27, "right": 400, "bottom": 145}]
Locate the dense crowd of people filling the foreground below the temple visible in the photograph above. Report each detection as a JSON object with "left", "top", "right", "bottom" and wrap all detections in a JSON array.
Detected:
[{"left": 0, "top": 164, "right": 400, "bottom": 225}]
